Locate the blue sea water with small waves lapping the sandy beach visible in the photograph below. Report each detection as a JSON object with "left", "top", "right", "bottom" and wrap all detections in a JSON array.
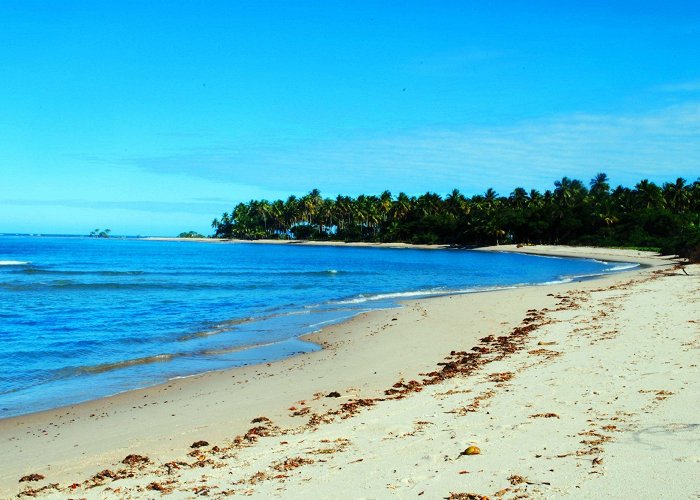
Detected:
[{"left": 0, "top": 236, "right": 631, "bottom": 418}]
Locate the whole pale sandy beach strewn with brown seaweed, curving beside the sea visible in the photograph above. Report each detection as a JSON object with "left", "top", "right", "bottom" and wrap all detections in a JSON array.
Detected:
[{"left": 0, "top": 247, "right": 700, "bottom": 498}]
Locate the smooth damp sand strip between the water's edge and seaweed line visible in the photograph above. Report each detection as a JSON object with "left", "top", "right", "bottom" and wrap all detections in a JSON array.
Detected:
[{"left": 0, "top": 247, "right": 688, "bottom": 494}]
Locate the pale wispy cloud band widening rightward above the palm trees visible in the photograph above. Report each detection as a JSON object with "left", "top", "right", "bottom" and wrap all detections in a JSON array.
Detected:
[{"left": 131, "top": 102, "right": 700, "bottom": 194}]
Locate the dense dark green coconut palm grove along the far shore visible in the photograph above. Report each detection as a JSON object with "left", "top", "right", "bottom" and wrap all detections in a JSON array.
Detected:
[{"left": 212, "top": 173, "right": 700, "bottom": 257}]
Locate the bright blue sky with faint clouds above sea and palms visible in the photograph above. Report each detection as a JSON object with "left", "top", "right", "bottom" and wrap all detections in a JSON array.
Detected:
[{"left": 0, "top": 0, "right": 700, "bottom": 236}]
